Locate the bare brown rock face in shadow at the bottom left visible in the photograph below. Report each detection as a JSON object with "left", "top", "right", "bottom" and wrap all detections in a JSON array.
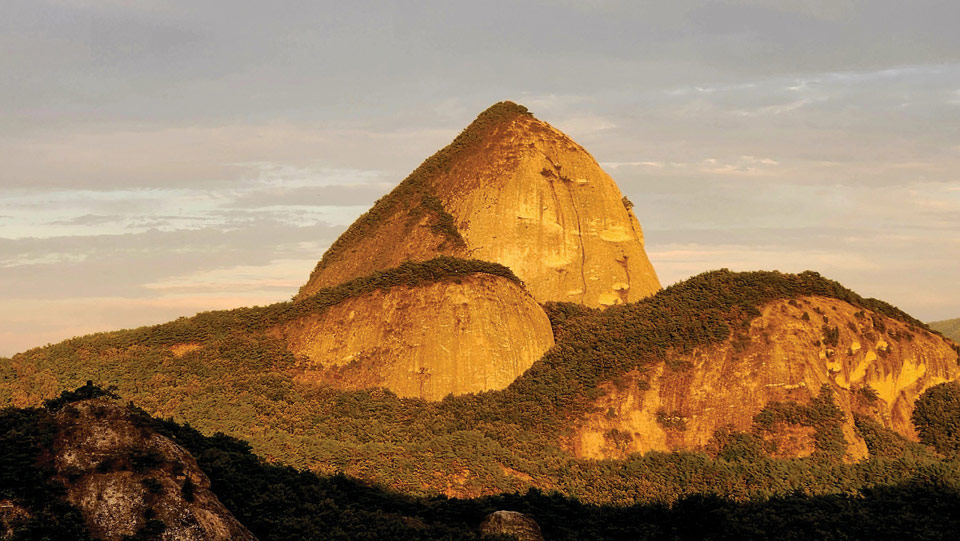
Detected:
[{"left": 53, "top": 399, "right": 254, "bottom": 541}]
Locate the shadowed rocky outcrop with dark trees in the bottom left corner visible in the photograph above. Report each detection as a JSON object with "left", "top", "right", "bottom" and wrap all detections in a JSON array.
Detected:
[{"left": 0, "top": 386, "right": 254, "bottom": 541}]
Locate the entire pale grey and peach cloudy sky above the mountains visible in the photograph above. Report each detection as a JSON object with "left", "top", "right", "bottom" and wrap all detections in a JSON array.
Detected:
[{"left": 0, "top": 0, "right": 960, "bottom": 355}]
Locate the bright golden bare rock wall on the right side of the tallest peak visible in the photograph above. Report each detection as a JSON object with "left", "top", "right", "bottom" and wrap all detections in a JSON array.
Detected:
[{"left": 437, "top": 117, "right": 660, "bottom": 306}]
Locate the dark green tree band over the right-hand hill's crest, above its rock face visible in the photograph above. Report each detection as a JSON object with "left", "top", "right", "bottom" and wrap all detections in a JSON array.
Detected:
[{"left": 440, "top": 270, "right": 925, "bottom": 434}]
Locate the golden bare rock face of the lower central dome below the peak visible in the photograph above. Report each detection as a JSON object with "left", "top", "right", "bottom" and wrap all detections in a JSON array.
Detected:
[{"left": 275, "top": 273, "right": 553, "bottom": 400}]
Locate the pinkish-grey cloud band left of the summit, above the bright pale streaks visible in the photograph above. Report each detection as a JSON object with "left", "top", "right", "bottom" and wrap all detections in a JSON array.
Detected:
[{"left": 0, "top": 124, "right": 456, "bottom": 190}]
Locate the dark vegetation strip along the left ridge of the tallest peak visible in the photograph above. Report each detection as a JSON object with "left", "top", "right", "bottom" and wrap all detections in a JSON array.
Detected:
[{"left": 301, "top": 101, "right": 531, "bottom": 293}]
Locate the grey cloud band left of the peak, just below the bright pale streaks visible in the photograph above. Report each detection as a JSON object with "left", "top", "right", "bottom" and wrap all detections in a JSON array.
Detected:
[{"left": 0, "top": 220, "right": 343, "bottom": 299}]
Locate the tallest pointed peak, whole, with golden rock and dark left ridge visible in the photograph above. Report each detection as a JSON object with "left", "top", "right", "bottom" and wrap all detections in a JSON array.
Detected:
[{"left": 299, "top": 102, "right": 660, "bottom": 306}]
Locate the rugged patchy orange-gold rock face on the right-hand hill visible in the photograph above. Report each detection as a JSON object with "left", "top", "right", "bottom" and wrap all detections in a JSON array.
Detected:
[{"left": 570, "top": 297, "right": 960, "bottom": 460}]
